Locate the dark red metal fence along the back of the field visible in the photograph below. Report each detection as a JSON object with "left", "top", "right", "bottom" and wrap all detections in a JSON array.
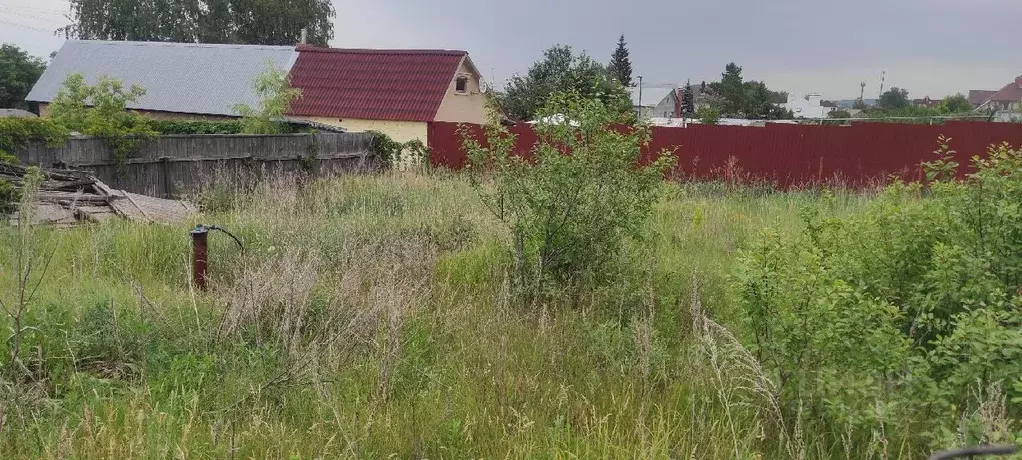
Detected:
[{"left": 428, "top": 122, "right": 1022, "bottom": 187}]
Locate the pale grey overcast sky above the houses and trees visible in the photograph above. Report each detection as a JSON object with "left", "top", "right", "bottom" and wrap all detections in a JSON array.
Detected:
[{"left": 0, "top": 0, "right": 1022, "bottom": 99}]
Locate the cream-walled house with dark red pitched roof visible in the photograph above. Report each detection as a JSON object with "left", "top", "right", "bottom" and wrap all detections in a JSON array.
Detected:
[{"left": 289, "top": 45, "right": 485, "bottom": 141}]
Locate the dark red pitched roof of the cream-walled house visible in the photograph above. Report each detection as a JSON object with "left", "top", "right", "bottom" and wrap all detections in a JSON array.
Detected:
[{"left": 290, "top": 45, "right": 468, "bottom": 122}]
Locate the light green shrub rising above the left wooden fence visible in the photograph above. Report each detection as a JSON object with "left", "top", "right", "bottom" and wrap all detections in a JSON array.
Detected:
[{"left": 50, "top": 74, "right": 156, "bottom": 174}]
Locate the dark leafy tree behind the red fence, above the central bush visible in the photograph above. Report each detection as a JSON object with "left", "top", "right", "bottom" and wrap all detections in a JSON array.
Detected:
[{"left": 500, "top": 46, "right": 632, "bottom": 120}]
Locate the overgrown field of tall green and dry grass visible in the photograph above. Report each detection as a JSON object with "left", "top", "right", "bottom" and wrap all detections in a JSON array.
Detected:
[{"left": 0, "top": 167, "right": 1008, "bottom": 459}]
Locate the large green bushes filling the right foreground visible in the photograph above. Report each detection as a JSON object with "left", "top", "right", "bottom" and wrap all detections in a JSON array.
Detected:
[{"left": 738, "top": 138, "right": 1022, "bottom": 447}]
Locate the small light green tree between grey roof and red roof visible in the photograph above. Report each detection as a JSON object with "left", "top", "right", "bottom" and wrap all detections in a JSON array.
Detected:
[{"left": 234, "top": 63, "right": 301, "bottom": 134}]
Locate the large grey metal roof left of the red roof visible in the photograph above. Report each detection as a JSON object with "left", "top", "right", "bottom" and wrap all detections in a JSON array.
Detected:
[{"left": 27, "top": 40, "right": 298, "bottom": 116}]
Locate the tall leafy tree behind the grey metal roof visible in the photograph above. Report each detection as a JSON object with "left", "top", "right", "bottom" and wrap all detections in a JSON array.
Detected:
[{"left": 61, "top": 0, "right": 336, "bottom": 45}]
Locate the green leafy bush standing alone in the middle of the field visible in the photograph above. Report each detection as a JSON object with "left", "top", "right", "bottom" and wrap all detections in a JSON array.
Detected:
[{"left": 464, "top": 94, "right": 673, "bottom": 298}]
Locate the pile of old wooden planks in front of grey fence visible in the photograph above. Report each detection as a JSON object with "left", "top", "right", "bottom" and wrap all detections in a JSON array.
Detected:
[{"left": 0, "top": 163, "right": 198, "bottom": 226}]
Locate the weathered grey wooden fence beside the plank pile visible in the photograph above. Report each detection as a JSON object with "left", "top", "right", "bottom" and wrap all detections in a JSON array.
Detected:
[{"left": 14, "top": 133, "right": 379, "bottom": 197}]
